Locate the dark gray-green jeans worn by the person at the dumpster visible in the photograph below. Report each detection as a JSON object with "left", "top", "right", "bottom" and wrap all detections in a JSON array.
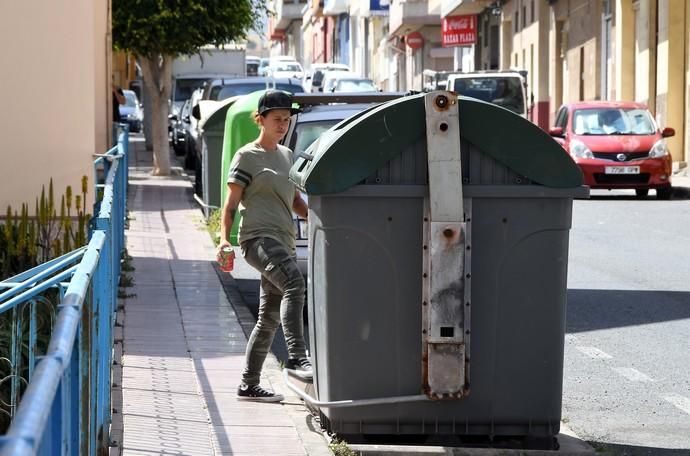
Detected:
[{"left": 241, "top": 237, "right": 307, "bottom": 385}]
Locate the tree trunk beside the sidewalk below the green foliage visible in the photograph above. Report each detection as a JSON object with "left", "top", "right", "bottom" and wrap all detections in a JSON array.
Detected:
[{"left": 138, "top": 55, "right": 173, "bottom": 176}]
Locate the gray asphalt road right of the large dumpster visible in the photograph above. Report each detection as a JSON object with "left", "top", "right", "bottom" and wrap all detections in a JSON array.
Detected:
[{"left": 563, "top": 189, "right": 690, "bottom": 456}]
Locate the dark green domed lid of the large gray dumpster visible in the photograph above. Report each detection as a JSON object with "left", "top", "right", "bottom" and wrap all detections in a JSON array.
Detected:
[{"left": 290, "top": 94, "right": 583, "bottom": 195}]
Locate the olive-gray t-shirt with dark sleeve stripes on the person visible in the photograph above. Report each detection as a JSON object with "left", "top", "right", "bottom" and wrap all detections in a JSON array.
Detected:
[{"left": 228, "top": 142, "right": 295, "bottom": 250}]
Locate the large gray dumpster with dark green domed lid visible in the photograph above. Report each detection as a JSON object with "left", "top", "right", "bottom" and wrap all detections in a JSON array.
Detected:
[{"left": 291, "top": 92, "right": 588, "bottom": 444}]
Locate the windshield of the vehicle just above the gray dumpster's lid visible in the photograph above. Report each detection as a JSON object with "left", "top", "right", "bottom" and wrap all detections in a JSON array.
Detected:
[{"left": 453, "top": 76, "right": 525, "bottom": 114}]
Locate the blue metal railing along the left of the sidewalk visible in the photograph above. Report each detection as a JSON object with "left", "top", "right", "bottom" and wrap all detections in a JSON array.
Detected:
[{"left": 0, "top": 126, "right": 129, "bottom": 456}]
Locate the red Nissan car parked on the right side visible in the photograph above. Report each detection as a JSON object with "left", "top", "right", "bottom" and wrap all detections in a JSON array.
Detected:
[{"left": 549, "top": 101, "right": 675, "bottom": 199}]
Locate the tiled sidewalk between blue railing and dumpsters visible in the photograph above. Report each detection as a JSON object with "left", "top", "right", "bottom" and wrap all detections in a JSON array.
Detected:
[{"left": 111, "top": 137, "right": 332, "bottom": 456}]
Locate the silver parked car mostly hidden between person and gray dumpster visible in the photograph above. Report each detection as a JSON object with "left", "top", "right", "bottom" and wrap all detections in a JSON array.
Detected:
[{"left": 282, "top": 93, "right": 402, "bottom": 275}]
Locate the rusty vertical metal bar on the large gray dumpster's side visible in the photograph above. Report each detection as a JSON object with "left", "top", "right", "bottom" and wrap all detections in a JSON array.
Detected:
[{"left": 422, "top": 92, "right": 470, "bottom": 399}]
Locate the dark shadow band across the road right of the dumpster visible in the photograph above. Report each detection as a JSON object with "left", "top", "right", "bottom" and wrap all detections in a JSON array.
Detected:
[{"left": 566, "top": 289, "right": 690, "bottom": 334}]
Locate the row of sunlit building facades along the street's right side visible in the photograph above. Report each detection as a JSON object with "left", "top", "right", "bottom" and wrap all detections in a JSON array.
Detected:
[{"left": 270, "top": 0, "right": 690, "bottom": 164}]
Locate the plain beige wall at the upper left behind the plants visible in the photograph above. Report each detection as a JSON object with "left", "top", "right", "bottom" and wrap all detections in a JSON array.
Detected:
[{"left": 0, "top": 0, "right": 111, "bottom": 212}]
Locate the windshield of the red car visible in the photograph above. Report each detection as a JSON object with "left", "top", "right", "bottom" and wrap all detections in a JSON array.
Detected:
[{"left": 573, "top": 108, "right": 656, "bottom": 135}]
